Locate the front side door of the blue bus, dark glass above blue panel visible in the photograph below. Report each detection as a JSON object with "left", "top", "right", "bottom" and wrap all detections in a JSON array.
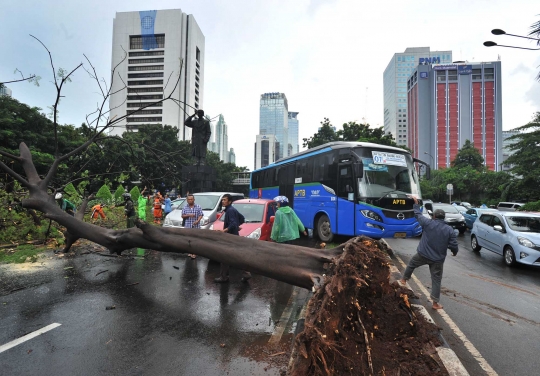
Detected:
[{"left": 337, "top": 164, "right": 356, "bottom": 236}]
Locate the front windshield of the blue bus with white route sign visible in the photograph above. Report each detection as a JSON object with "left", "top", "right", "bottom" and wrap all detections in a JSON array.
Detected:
[{"left": 355, "top": 148, "right": 421, "bottom": 200}]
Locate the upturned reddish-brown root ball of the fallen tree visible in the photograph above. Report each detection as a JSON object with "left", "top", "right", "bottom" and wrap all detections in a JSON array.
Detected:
[{"left": 289, "top": 237, "right": 448, "bottom": 376}]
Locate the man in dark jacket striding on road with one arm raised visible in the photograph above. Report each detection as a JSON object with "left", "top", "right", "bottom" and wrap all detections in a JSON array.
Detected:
[{"left": 399, "top": 197, "right": 458, "bottom": 309}]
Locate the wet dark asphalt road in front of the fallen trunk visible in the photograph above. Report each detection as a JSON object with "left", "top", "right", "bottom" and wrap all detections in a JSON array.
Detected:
[{"left": 0, "top": 248, "right": 308, "bottom": 376}]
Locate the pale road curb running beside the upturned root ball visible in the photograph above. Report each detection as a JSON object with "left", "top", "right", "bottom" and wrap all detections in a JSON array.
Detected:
[{"left": 379, "top": 239, "right": 469, "bottom": 376}]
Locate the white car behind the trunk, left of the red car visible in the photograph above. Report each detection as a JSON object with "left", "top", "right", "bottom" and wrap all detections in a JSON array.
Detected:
[{"left": 163, "top": 192, "right": 244, "bottom": 229}]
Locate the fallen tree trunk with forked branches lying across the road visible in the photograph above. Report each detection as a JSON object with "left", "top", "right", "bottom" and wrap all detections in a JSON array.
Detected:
[{"left": 9, "top": 143, "right": 343, "bottom": 289}]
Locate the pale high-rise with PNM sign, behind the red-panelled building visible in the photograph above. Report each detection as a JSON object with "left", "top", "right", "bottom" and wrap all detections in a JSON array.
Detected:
[{"left": 383, "top": 47, "right": 452, "bottom": 145}]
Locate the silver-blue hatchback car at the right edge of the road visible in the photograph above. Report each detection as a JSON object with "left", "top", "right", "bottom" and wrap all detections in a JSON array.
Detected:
[{"left": 471, "top": 212, "right": 540, "bottom": 266}]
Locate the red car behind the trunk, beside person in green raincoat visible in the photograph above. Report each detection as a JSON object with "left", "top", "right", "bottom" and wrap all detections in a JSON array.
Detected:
[{"left": 210, "top": 198, "right": 276, "bottom": 240}]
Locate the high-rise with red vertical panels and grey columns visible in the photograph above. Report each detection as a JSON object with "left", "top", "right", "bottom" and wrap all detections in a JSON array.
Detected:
[{"left": 410, "top": 61, "right": 503, "bottom": 171}]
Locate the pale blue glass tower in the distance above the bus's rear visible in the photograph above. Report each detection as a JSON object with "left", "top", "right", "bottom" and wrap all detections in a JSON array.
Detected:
[{"left": 255, "top": 93, "right": 289, "bottom": 168}]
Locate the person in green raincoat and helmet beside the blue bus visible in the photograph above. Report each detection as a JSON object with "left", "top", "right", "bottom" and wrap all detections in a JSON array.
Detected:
[{"left": 270, "top": 196, "right": 307, "bottom": 244}]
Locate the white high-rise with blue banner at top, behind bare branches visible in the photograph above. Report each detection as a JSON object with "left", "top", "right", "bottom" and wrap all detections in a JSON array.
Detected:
[{"left": 109, "top": 9, "right": 205, "bottom": 140}]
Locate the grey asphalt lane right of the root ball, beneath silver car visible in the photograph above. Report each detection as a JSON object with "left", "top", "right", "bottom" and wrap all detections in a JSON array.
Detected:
[{"left": 386, "top": 232, "right": 540, "bottom": 376}]
